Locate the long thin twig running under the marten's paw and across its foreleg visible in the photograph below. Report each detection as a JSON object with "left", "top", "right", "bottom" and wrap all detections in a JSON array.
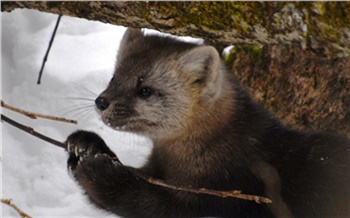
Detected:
[{"left": 1, "top": 115, "right": 272, "bottom": 204}]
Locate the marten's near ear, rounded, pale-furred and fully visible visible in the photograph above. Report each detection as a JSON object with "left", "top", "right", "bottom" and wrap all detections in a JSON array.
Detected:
[{"left": 178, "top": 46, "right": 223, "bottom": 98}]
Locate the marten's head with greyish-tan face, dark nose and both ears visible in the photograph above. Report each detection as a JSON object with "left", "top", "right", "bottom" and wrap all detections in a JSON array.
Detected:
[{"left": 95, "top": 28, "right": 223, "bottom": 138}]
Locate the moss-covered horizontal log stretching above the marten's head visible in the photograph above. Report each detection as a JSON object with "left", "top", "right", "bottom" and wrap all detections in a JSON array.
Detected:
[{"left": 2, "top": 1, "right": 350, "bottom": 57}]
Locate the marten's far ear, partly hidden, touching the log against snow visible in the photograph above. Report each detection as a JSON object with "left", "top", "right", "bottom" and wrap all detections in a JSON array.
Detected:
[{"left": 117, "top": 27, "right": 143, "bottom": 64}]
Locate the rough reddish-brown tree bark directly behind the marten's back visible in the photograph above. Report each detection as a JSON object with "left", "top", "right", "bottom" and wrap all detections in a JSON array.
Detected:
[{"left": 226, "top": 45, "right": 350, "bottom": 137}]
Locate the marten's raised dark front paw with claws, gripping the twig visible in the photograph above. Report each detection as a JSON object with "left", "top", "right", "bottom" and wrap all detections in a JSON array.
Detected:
[{"left": 65, "top": 131, "right": 118, "bottom": 174}]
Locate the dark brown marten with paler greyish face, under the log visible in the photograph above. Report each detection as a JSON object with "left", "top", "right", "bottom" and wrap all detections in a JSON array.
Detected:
[{"left": 66, "top": 28, "right": 350, "bottom": 218}]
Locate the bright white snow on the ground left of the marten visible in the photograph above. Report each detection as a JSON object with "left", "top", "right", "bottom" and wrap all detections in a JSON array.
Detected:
[{"left": 0, "top": 9, "right": 152, "bottom": 217}]
